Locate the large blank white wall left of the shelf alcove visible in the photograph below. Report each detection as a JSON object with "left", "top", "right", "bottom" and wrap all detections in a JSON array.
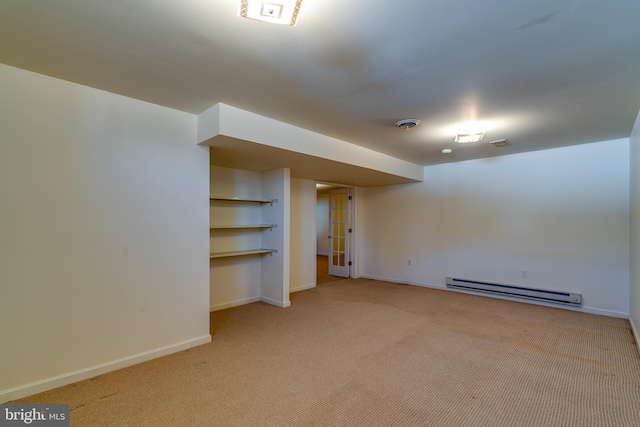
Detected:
[{"left": 0, "top": 65, "right": 211, "bottom": 401}]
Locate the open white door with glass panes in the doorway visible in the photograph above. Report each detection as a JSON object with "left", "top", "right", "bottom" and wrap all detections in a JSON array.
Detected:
[{"left": 329, "top": 188, "right": 350, "bottom": 277}]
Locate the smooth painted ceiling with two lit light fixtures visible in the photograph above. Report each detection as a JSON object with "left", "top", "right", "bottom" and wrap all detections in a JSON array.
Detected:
[{"left": 0, "top": 0, "right": 640, "bottom": 165}]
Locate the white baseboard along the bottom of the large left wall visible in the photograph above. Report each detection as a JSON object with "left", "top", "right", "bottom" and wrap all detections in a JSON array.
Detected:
[{"left": 0, "top": 334, "right": 211, "bottom": 403}]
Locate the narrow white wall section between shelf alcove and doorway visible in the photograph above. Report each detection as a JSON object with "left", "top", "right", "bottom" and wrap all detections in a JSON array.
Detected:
[{"left": 289, "top": 178, "right": 316, "bottom": 292}]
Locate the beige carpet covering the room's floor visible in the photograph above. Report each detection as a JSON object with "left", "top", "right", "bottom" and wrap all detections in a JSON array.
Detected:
[{"left": 10, "top": 279, "right": 640, "bottom": 427}]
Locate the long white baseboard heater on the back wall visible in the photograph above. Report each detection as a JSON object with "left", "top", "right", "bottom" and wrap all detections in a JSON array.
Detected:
[{"left": 447, "top": 277, "right": 582, "bottom": 306}]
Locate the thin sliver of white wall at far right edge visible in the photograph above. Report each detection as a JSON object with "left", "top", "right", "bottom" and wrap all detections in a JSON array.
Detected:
[{"left": 629, "top": 113, "right": 640, "bottom": 350}]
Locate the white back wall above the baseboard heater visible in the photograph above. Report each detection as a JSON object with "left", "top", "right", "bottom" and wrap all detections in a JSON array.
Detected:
[{"left": 358, "top": 139, "right": 629, "bottom": 317}]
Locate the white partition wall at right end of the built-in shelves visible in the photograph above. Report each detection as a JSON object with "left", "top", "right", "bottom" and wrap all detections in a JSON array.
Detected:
[{"left": 260, "top": 169, "right": 291, "bottom": 307}]
